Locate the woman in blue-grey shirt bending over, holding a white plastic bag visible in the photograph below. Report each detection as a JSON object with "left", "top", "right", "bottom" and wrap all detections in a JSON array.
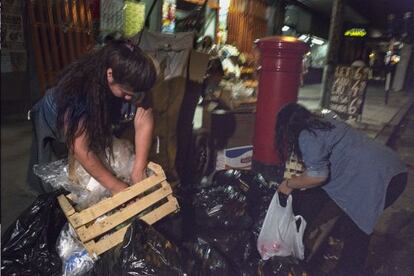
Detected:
[{"left": 276, "top": 103, "right": 407, "bottom": 275}]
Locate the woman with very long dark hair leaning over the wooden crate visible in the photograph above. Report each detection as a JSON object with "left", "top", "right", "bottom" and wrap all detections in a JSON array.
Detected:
[{"left": 28, "top": 40, "right": 156, "bottom": 194}]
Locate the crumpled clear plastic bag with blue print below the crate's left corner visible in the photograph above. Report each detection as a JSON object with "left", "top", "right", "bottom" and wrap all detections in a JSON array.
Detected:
[{"left": 56, "top": 223, "right": 94, "bottom": 276}]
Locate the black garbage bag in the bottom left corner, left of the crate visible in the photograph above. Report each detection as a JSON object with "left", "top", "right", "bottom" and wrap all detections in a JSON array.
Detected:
[{"left": 1, "top": 192, "right": 66, "bottom": 275}]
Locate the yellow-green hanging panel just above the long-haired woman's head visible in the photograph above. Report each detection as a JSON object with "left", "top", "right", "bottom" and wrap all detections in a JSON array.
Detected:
[{"left": 123, "top": 1, "right": 145, "bottom": 38}]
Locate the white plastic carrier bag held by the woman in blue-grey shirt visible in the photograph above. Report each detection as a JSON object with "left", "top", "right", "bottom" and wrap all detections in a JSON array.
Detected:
[{"left": 257, "top": 192, "right": 306, "bottom": 260}]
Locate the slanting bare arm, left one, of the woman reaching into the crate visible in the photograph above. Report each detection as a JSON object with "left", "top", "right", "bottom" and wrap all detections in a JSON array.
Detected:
[{"left": 72, "top": 129, "right": 128, "bottom": 194}]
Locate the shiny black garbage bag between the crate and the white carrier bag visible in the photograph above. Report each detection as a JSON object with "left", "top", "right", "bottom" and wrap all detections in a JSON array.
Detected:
[{"left": 193, "top": 185, "right": 252, "bottom": 230}]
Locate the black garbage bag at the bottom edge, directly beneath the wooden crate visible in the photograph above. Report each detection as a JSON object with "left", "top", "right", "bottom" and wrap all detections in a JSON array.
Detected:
[{"left": 89, "top": 219, "right": 185, "bottom": 276}]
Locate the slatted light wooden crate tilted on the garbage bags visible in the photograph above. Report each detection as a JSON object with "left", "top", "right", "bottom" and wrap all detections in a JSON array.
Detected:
[{"left": 58, "top": 162, "right": 179, "bottom": 258}]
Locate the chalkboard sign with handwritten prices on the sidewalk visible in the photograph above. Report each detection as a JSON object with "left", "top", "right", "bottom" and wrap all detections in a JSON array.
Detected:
[{"left": 329, "top": 66, "right": 369, "bottom": 119}]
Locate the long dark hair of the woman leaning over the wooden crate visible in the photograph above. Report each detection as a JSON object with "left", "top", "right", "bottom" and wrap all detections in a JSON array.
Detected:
[{"left": 56, "top": 40, "right": 156, "bottom": 154}]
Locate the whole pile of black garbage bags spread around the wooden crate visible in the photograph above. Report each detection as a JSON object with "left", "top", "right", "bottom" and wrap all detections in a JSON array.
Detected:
[{"left": 1, "top": 170, "right": 305, "bottom": 276}]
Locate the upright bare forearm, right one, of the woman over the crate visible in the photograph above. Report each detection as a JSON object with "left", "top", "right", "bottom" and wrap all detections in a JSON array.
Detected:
[{"left": 131, "top": 107, "right": 154, "bottom": 184}]
